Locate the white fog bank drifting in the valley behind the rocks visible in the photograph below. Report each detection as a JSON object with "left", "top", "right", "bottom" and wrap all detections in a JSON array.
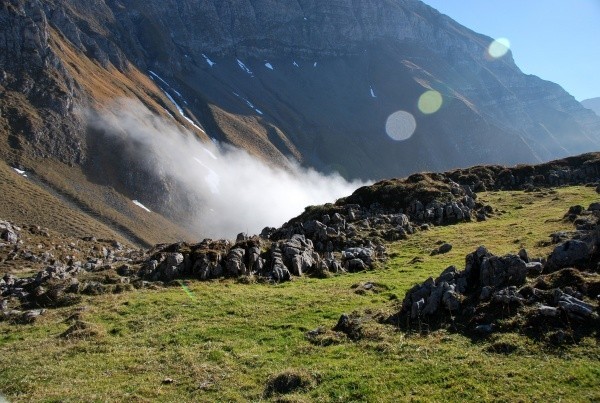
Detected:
[{"left": 88, "top": 100, "right": 365, "bottom": 238}]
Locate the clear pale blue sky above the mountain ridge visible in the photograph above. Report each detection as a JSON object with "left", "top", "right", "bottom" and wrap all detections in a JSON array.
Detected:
[{"left": 423, "top": 0, "right": 600, "bottom": 101}]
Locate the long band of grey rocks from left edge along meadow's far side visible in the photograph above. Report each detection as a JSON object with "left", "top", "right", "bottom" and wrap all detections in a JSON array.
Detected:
[{"left": 0, "top": 169, "right": 482, "bottom": 322}]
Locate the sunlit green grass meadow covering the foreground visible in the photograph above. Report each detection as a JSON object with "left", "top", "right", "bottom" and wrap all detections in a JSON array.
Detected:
[{"left": 0, "top": 187, "right": 600, "bottom": 401}]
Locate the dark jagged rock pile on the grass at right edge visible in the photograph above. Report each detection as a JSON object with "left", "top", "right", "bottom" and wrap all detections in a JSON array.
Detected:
[{"left": 389, "top": 203, "right": 600, "bottom": 344}]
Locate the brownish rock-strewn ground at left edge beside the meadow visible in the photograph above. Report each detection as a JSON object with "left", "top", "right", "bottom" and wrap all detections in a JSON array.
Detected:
[{"left": 0, "top": 221, "right": 143, "bottom": 323}]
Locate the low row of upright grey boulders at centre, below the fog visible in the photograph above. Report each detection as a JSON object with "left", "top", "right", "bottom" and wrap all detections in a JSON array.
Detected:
[{"left": 136, "top": 234, "right": 385, "bottom": 282}]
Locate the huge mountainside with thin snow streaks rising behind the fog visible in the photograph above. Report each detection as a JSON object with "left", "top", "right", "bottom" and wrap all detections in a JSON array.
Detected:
[{"left": 0, "top": 0, "right": 600, "bottom": 237}]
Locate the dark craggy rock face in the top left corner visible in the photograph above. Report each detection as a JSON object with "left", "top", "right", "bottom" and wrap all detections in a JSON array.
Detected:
[{"left": 0, "top": 0, "right": 85, "bottom": 164}]
